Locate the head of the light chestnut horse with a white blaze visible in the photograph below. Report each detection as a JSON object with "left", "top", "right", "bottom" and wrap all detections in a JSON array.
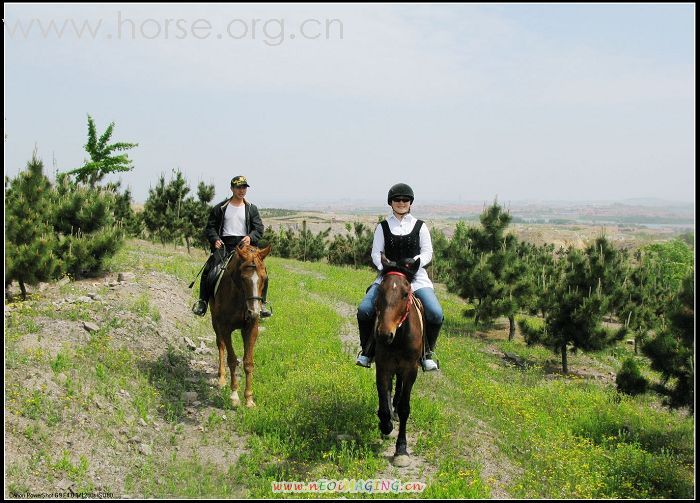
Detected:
[{"left": 231, "top": 245, "right": 272, "bottom": 320}]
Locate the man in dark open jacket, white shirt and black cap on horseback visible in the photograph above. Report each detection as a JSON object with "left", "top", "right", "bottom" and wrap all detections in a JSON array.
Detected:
[{"left": 192, "top": 176, "right": 272, "bottom": 318}]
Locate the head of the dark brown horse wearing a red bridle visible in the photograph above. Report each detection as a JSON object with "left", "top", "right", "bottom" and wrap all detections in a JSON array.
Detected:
[{"left": 375, "top": 254, "right": 420, "bottom": 345}]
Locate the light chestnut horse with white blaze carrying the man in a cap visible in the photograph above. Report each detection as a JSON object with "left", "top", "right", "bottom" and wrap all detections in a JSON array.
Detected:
[{"left": 210, "top": 245, "right": 272, "bottom": 407}]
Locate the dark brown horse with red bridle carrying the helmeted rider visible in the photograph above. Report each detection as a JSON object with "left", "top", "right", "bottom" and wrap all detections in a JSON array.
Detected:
[{"left": 375, "top": 256, "right": 424, "bottom": 466}]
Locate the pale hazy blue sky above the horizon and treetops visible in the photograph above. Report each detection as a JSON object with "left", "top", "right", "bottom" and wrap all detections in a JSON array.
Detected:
[{"left": 4, "top": 4, "right": 695, "bottom": 206}]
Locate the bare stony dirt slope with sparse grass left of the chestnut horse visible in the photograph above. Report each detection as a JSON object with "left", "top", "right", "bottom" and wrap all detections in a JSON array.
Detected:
[{"left": 4, "top": 272, "right": 247, "bottom": 497}]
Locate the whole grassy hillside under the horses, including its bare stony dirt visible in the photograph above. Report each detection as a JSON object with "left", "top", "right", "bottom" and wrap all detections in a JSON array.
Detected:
[{"left": 5, "top": 241, "right": 694, "bottom": 498}]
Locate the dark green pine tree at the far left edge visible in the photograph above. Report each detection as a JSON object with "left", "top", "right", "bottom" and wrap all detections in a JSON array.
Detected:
[{"left": 5, "top": 151, "right": 63, "bottom": 299}]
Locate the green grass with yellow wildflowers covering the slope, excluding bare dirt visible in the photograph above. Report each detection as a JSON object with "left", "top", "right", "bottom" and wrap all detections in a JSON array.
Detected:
[{"left": 5, "top": 241, "right": 695, "bottom": 499}]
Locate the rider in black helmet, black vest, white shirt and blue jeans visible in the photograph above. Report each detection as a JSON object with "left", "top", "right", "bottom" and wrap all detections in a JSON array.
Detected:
[{"left": 356, "top": 183, "right": 444, "bottom": 371}]
